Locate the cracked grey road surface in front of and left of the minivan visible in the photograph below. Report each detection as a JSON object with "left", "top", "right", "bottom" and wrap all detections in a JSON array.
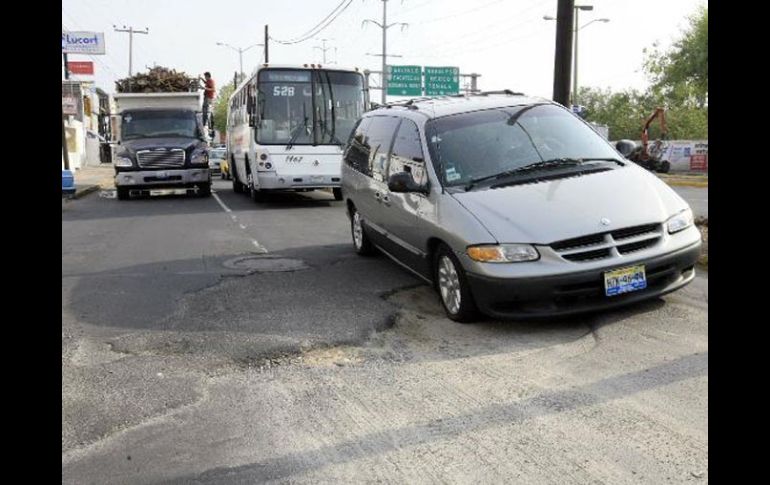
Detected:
[{"left": 62, "top": 181, "right": 708, "bottom": 484}]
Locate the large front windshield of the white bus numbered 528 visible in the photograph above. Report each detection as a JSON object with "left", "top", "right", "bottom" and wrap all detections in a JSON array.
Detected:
[{"left": 257, "top": 69, "right": 364, "bottom": 145}]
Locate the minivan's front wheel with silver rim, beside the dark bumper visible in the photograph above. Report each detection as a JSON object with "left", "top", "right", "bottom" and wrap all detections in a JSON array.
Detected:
[{"left": 435, "top": 245, "right": 478, "bottom": 323}]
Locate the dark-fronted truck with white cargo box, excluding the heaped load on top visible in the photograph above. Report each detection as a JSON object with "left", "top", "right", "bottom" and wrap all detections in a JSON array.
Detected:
[{"left": 113, "top": 93, "right": 211, "bottom": 200}]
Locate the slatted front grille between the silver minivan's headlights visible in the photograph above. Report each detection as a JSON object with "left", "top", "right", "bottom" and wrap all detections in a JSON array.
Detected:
[{"left": 550, "top": 224, "right": 663, "bottom": 262}]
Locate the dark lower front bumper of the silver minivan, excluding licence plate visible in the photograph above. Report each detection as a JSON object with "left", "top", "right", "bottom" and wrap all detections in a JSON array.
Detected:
[{"left": 467, "top": 242, "right": 701, "bottom": 319}]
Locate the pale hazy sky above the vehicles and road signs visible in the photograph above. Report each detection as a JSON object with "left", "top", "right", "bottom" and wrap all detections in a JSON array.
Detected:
[{"left": 62, "top": 0, "right": 708, "bottom": 100}]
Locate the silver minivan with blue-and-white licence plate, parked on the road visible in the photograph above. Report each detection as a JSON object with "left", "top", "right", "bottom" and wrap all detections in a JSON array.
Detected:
[{"left": 342, "top": 91, "right": 701, "bottom": 322}]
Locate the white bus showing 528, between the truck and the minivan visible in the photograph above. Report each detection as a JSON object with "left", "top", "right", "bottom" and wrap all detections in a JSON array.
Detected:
[{"left": 227, "top": 64, "right": 369, "bottom": 201}]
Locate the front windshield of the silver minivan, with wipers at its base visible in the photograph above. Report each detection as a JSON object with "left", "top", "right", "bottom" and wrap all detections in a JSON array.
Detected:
[{"left": 426, "top": 104, "right": 619, "bottom": 186}]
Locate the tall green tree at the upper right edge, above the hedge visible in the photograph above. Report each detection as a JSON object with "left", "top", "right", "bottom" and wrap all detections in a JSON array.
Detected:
[{"left": 644, "top": 6, "right": 708, "bottom": 108}]
